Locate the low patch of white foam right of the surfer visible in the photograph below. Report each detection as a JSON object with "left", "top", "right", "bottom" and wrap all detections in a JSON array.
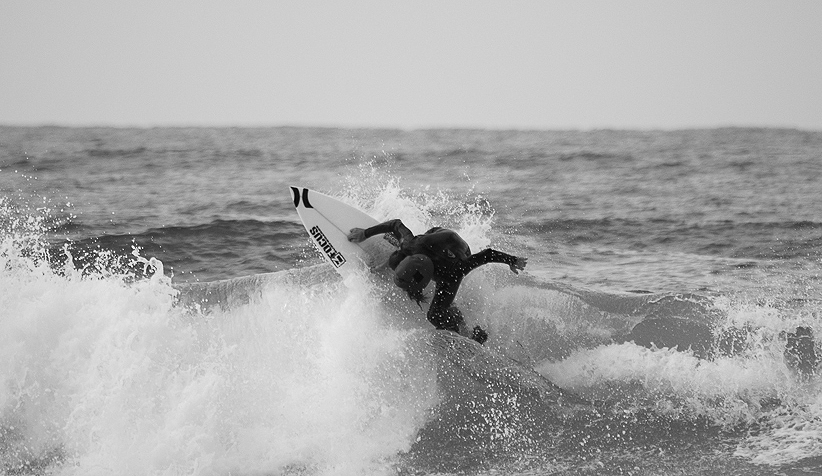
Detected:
[{"left": 537, "top": 343, "right": 791, "bottom": 429}]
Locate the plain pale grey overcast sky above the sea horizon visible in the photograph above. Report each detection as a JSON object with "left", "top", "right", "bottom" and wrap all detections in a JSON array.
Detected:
[{"left": 0, "top": 0, "right": 822, "bottom": 130}]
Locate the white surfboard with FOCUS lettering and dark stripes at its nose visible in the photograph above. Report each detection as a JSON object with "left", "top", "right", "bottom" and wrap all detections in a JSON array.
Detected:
[{"left": 291, "top": 187, "right": 396, "bottom": 276}]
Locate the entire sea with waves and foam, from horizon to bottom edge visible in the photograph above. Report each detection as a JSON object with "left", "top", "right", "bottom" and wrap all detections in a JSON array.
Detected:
[{"left": 0, "top": 127, "right": 822, "bottom": 475}]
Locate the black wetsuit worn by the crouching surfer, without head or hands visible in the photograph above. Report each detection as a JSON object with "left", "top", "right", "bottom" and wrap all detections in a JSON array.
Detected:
[{"left": 365, "top": 219, "right": 517, "bottom": 332}]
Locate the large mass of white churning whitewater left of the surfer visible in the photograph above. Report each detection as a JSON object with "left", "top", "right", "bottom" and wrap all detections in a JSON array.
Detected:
[{"left": 0, "top": 209, "right": 444, "bottom": 474}]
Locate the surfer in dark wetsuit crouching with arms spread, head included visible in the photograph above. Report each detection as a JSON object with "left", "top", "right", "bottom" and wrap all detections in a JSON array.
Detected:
[{"left": 348, "top": 219, "right": 528, "bottom": 344}]
